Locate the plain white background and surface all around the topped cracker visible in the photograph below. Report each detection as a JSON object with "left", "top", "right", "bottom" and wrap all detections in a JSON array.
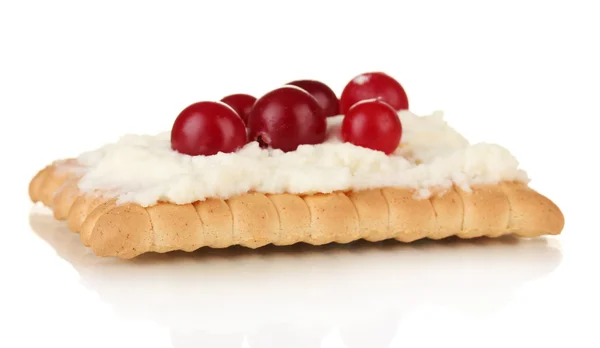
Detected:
[{"left": 0, "top": 0, "right": 600, "bottom": 348}]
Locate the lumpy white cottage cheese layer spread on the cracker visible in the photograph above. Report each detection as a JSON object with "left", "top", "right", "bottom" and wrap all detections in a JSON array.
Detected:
[{"left": 78, "top": 111, "right": 528, "bottom": 206}]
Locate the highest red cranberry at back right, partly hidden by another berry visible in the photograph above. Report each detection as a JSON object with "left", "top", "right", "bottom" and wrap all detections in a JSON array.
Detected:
[{"left": 340, "top": 72, "right": 408, "bottom": 114}]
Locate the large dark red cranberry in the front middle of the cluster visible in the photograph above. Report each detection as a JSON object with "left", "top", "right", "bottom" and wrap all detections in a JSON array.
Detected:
[{"left": 248, "top": 86, "right": 327, "bottom": 152}]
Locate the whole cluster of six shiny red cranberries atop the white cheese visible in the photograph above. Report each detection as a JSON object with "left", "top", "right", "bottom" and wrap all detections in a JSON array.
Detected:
[{"left": 171, "top": 72, "right": 408, "bottom": 156}]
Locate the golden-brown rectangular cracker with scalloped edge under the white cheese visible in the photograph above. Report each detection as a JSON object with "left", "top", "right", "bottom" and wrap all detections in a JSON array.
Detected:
[{"left": 29, "top": 160, "right": 564, "bottom": 259}]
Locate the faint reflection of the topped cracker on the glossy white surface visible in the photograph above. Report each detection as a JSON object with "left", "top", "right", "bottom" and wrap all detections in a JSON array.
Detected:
[{"left": 30, "top": 207, "right": 561, "bottom": 348}]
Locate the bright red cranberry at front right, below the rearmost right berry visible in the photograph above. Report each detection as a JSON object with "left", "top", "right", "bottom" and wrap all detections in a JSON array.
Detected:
[{"left": 342, "top": 99, "right": 402, "bottom": 155}]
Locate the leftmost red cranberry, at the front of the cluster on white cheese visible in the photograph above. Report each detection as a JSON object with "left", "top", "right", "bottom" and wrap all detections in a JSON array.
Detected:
[{"left": 171, "top": 101, "right": 246, "bottom": 156}]
